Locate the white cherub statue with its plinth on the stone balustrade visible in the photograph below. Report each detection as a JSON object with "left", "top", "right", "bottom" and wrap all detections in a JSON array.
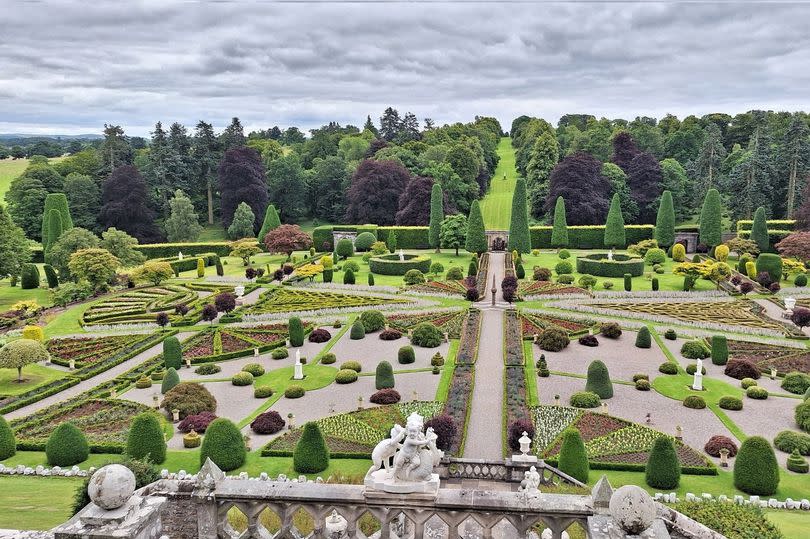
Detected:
[{"left": 365, "top": 412, "right": 444, "bottom": 494}]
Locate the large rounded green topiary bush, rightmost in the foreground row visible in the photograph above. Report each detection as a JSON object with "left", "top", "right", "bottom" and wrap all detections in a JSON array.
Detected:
[{"left": 734, "top": 436, "right": 779, "bottom": 496}]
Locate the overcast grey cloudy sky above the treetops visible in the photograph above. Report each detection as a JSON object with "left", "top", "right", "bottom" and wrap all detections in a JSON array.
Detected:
[{"left": 0, "top": 0, "right": 810, "bottom": 135}]
